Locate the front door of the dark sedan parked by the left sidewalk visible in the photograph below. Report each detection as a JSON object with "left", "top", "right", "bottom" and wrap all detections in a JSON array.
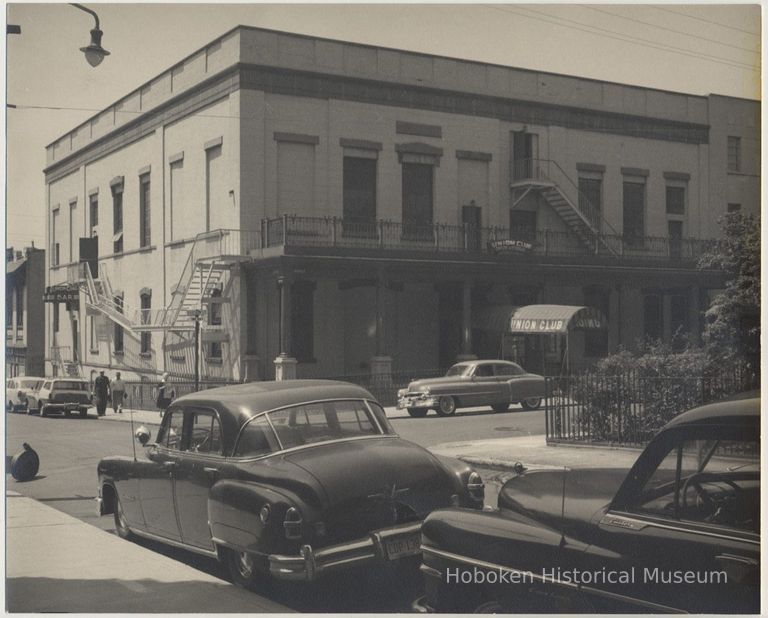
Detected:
[{"left": 139, "top": 407, "right": 184, "bottom": 541}]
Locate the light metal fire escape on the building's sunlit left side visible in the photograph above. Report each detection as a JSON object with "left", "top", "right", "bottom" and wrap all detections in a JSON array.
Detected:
[{"left": 81, "top": 230, "right": 250, "bottom": 337}]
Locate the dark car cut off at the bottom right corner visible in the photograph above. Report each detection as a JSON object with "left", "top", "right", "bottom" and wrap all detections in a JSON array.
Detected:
[{"left": 416, "top": 398, "right": 760, "bottom": 613}]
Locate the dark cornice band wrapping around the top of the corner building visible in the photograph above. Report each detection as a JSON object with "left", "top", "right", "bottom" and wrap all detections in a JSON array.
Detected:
[{"left": 44, "top": 64, "right": 709, "bottom": 182}]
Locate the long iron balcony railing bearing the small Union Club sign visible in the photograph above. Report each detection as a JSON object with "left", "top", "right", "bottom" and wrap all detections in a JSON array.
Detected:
[{"left": 262, "top": 216, "right": 712, "bottom": 260}]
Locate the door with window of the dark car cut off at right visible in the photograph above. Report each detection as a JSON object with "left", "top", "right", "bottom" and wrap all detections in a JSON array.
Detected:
[{"left": 585, "top": 426, "right": 760, "bottom": 613}]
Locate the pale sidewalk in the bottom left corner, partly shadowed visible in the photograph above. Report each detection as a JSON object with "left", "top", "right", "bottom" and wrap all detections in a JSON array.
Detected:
[{"left": 5, "top": 491, "right": 291, "bottom": 613}]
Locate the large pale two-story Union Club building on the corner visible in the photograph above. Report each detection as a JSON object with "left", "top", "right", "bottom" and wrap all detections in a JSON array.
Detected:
[{"left": 45, "top": 27, "right": 759, "bottom": 379}]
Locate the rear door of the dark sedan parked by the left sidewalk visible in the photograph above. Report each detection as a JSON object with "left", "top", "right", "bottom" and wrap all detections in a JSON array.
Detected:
[{"left": 175, "top": 407, "right": 224, "bottom": 550}]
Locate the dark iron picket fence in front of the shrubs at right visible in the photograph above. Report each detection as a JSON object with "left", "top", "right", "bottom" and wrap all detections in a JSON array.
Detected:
[{"left": 545, "top": 365, "right": 759, "bottom": 446}]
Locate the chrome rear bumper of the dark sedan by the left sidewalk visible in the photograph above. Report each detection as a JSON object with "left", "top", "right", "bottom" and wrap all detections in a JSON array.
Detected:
[{"left": 269, "top": 522, "right": 421, "bottom": 581}]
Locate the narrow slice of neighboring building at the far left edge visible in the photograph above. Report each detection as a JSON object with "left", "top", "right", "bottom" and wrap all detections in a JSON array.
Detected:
[{"left": 5, "top": 247, "right": 46, "bottom": 378}]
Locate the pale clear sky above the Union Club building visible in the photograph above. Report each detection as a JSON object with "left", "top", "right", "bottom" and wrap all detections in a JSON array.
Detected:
[{"left": 5, "top": 3, "right": 761, "bottom": 249}]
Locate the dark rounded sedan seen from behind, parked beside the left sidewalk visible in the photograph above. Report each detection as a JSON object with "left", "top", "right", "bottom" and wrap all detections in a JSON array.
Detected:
[{"left": 98, "top": 380, "right": 484, "bottom": 588}]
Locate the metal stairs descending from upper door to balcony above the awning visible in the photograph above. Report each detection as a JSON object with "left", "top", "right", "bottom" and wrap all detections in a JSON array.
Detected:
[{"left": 511, "top": 159, "right": 619, "bottom": 255}]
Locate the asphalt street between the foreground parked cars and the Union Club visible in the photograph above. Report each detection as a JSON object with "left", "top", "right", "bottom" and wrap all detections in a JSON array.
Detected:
[{"left": 6, "top": 408, "right": 544, "bottom": 612}]
